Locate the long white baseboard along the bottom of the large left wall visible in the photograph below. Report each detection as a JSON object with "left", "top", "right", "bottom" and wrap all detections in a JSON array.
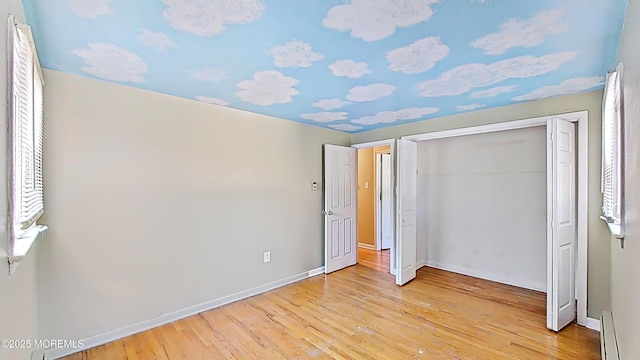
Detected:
[{"left": 46, "top": 266, "right": 324, "bottom": 360}]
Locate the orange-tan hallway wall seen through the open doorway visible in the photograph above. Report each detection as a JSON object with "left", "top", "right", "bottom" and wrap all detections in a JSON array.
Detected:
[{"left": 358, "top": 148, "right": 376, "bottom": 246}]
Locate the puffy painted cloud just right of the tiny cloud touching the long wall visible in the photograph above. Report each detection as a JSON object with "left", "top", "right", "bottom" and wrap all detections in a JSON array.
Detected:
[{"left": 235, "top": 70, "right": 299, "bottom": 106}]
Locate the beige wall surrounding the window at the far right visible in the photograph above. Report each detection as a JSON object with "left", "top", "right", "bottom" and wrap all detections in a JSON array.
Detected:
[{"left": 607, "top": 1, "right": 640, "bottom": 360}]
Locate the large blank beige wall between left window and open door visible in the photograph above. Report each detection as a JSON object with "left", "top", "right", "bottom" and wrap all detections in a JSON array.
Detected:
[{"left": 38, "top": 71, "right": 350, "bottom": 339}]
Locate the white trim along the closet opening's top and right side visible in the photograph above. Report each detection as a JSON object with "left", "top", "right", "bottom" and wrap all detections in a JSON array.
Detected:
[{"left": 402, "top": 111, "right": 599, "bottom": 330}]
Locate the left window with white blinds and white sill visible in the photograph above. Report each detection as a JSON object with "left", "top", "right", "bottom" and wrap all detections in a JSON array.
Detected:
[{"left": 7, "top": 16, "right": 46, "bottom": 270}]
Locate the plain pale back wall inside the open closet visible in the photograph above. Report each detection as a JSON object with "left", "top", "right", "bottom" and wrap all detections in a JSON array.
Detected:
[{"left": 418, "top": 127, "right": 547, "bottom": 291}]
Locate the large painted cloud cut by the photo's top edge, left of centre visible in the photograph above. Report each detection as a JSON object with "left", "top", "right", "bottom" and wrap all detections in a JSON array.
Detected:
[{"left": 165, "top": 0, "right": 264, "bottom": 36}]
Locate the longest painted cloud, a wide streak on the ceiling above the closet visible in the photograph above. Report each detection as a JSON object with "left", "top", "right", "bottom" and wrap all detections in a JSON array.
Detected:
[{"left": 417, "top": 52, "right": 577, "bottom": 97}]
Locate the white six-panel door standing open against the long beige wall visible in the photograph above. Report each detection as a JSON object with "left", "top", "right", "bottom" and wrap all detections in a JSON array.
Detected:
[{"left": 323, "top": 144, "right": 358, "bottom": 274}]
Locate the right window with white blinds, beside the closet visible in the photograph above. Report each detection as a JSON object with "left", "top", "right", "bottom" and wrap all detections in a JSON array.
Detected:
[{"left": 602, "top": 64, "right": 623, "bottom": 237}]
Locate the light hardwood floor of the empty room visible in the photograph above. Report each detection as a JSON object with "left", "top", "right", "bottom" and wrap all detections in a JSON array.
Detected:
[{"left": 66, "top": 249, "right": 600, "bottom": 360}]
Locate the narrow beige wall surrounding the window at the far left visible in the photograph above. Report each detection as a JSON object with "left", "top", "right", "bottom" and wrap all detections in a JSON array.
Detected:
[{"left": 0, "top": 0, "right": 38, "bottom": 359}]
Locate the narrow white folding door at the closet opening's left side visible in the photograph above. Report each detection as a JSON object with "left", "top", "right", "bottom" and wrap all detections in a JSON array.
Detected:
[{"left": 396, "top": 139, "right": 418, "bottom": 285}]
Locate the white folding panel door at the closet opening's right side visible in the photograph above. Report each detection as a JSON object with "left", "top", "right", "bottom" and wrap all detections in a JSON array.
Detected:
[{"left": 547, "top": 119, "right": 577, "bottom": 331}]
